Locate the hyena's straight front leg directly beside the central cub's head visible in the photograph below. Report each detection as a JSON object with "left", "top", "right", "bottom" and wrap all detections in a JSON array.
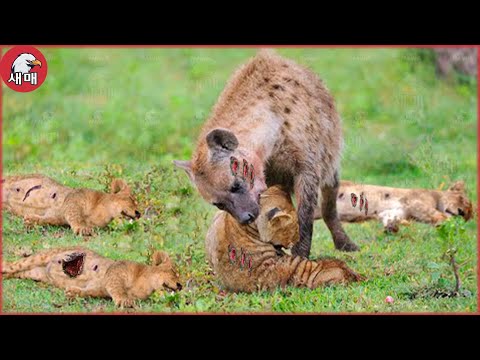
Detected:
[{"left": 292, "top": 174, "right": 320, "bottom": 258}]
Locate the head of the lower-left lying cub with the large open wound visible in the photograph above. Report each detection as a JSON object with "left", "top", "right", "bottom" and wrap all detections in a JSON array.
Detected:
[{"left": 150, "top": 251, "right": 182, "bottom": 291}]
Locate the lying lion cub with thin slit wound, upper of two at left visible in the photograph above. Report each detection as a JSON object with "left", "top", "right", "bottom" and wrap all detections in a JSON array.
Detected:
[{"left": 2, "top": 174, "right": 140, "bottom": 235}]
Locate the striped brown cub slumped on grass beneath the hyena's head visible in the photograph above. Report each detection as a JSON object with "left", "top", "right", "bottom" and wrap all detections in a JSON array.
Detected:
[{"left": 206, "top": 186, "right": 361, "bottom": 292}]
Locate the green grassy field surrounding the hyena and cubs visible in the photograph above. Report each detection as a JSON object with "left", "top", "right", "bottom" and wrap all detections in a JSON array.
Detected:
[{"left": 3, "top": 48, "right": 477, "bottom": 312}]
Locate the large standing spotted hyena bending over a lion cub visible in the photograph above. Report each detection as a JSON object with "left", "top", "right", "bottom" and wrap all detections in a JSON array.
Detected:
[{"left": 176, "top": 50, "right": 358, "bottom": 257}]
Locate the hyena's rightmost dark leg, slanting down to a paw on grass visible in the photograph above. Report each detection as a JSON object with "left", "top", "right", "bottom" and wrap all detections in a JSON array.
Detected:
[{"left": 322, "top": 173, "right": 359, "bottom": 251}]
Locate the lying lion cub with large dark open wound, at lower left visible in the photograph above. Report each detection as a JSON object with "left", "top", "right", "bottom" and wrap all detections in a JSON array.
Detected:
[{"left": 2, "top": 247, "right": 182, "bottom": 307}]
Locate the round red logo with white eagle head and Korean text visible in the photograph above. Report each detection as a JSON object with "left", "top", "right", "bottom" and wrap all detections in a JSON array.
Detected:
[{"left": 0, "top": 46, "right": 48, "bottom": 92}]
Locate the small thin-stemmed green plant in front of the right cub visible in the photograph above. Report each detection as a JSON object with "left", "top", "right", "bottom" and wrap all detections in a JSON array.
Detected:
[{"left": 437, "top": 216, "right": 466, "bottom": 296}]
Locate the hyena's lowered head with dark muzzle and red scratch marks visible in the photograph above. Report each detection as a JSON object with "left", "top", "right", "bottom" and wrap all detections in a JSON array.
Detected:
[{"left": 174, "top": 128, "right": 267, "bottom": 224}]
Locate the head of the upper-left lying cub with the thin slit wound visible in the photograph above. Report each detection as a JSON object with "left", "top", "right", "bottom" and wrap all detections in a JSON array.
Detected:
[{"left": 109, "top": 179, "right": 141, "bottom": 219}]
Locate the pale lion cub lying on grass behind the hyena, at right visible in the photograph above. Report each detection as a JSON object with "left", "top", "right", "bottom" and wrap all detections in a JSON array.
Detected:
[{"left": 315, "top": 181, "right": 473, "bottom": 232}]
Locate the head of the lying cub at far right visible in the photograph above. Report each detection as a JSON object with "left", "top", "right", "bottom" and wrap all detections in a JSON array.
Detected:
[{"left": 439, "top": 181, "right": 473, "bottom": 220}]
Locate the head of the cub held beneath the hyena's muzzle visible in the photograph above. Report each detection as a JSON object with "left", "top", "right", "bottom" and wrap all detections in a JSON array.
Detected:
[{"left": 256, "top": 186, "right": 299, "bottom": 248}]
